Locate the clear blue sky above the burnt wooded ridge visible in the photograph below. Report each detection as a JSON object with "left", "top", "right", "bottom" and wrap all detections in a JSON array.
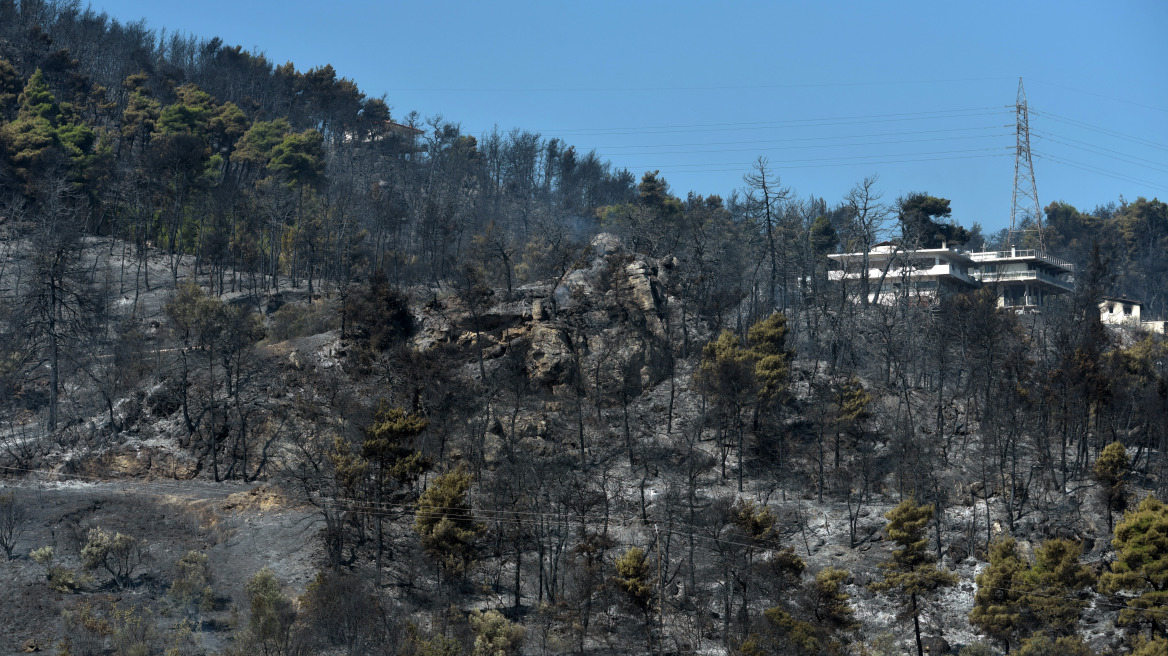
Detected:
[{"left": 92, "top": 0, "right": 1168, "bottom": 230}]
